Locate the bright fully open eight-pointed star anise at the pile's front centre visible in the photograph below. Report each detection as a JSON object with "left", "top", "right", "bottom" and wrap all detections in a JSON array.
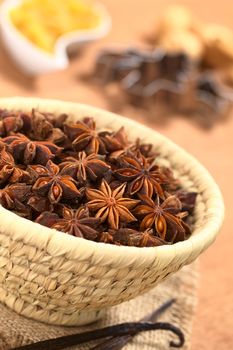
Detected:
[{"left": 86, "top": 180, "right": 139, "bottom": 229}]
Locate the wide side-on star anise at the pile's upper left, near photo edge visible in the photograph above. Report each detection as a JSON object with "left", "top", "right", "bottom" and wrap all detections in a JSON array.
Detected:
[{"left": 2, "top": 134, "right": 62, "bottom": 165}]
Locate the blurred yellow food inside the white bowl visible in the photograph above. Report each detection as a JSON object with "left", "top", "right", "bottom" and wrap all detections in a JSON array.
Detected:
[{"left": 10, "top": 0, "right": 101, "bottom": 52}]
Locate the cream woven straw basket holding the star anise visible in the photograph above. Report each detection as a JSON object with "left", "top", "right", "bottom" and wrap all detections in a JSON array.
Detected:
[{"left": 0, "top": 98, "right": 224, "bottom": 325}]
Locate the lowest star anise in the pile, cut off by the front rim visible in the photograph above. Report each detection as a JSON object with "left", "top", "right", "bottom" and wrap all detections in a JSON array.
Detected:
[{"left": 110, "top": 228, "right": 167, "bottom": 247}]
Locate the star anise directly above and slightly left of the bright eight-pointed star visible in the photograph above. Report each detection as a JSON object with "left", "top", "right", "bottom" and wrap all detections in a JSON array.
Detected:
[{"left": 59, "top": 151, "right": 110, "bottom": 182}]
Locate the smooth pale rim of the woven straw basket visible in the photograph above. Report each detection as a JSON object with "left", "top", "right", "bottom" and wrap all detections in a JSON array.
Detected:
[{"left": 0, "top": 97, "right": 224, "bottom": 265}]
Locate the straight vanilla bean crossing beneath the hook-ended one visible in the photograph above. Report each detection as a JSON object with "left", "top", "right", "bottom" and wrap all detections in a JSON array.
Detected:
[{"left": 91, "top": 299, "right": 175, "bottom": 350}]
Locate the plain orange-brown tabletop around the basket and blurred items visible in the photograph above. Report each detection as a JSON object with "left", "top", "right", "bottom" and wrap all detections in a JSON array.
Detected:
[{"left": 0, "top": 0, "right": 233, "bottom": 350}]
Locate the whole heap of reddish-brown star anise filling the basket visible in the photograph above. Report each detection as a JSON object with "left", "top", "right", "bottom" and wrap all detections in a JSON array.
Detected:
[{"left": 0, "top": 110, "right": 196, "bottom": 247}]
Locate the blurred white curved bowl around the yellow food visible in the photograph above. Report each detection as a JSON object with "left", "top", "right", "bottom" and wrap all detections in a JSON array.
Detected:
[{"left": 0, "top": 0, "right": 111, "bottom": 75}]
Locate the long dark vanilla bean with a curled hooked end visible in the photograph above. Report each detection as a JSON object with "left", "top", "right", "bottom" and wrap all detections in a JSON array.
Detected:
[{"left": 12, "top": 322, "right": 184, "bottom": 350}]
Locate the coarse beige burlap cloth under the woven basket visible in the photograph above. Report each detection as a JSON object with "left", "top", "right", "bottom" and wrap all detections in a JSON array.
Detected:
[{"left": 0, "top": 263, "right": 198, "bottom": 350}]
